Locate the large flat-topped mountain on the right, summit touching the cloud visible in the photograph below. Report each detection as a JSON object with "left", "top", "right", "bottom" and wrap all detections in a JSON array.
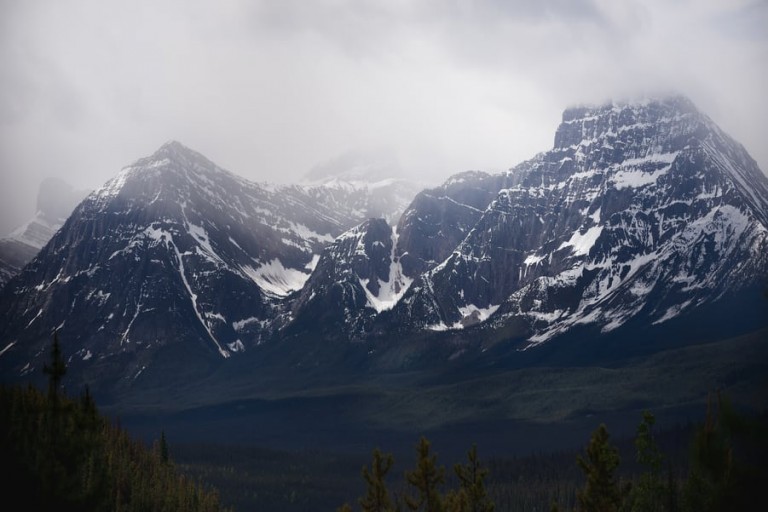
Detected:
[{"left": 388, "top": 97, "right": 768, "bottom": 344}]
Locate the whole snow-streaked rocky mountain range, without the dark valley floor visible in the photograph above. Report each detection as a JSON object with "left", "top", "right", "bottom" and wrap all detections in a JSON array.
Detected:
[{"left": 0, "top": 96, "right": 768, "bottom": 412}]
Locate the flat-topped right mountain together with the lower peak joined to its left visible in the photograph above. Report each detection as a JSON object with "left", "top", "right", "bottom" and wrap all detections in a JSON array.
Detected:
[{"left": 272, "top": 96, "right": 768, "bottom": 348}]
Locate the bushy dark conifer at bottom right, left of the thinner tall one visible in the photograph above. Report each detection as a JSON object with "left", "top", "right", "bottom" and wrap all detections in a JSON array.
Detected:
[{"left": 576, "top": 424, "right": 622, "bottom": 512}]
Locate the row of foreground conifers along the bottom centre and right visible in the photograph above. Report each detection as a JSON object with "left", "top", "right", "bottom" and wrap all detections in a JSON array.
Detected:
[{"left": 337, "top": 400, "right": 768, "bottom": 512}]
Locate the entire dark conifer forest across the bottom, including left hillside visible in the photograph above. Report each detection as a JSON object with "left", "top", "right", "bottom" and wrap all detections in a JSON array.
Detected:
[{"left": 0, "top": 338, "right": 768, "bottom": 512}]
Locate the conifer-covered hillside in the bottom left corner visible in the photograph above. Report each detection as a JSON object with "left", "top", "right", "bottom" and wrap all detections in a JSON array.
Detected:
[{"left": 0, "top": 336, "right": 228, "bottom": 512}]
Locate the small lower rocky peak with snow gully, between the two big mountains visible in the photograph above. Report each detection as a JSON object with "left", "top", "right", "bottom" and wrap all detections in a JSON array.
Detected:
[{"left": 282, "top": 171, "right": 504, "bottom": 340}]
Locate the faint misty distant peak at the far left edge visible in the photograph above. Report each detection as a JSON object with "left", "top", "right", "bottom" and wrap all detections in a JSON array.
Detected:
[{"left": 0, "top": 178, "right": 88, "bottom": 288}]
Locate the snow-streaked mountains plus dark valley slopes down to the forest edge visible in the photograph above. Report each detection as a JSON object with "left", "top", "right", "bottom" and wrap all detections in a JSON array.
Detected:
[{"left": 0, "top": 96, "right": 768, "bottom": 456}]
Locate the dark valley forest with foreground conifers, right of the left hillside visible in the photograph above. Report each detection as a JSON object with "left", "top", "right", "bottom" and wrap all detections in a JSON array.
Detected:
[{"left": 170, "top": 400, "right": 768, "bottom": 512}]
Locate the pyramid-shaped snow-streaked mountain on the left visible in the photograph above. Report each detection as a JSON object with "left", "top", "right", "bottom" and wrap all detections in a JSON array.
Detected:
[{"left": 0, "top": 142, "right": 420, "bottom": 394}]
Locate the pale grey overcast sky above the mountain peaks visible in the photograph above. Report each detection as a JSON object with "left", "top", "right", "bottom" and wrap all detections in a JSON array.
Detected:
[{"left": 0, "top": 0, "right": 768, "bottom": 234}]
